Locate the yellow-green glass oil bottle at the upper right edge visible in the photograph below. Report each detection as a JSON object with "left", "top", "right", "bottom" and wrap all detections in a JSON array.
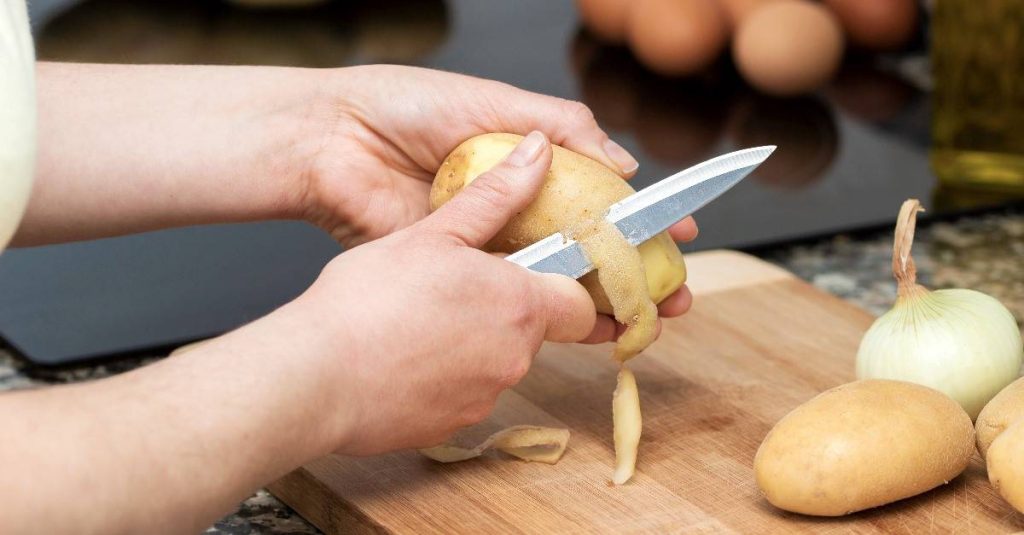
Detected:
[{"left": 931, "top": 0, "right": 1024, "bottom": 193}]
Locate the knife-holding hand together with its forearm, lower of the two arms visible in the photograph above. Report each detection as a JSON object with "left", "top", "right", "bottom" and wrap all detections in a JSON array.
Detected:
[{"left": 0, "top": 133, "right": 595, "bottom": 533}]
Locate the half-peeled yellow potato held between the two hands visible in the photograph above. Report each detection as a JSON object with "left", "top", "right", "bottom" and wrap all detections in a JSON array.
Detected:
[{"left": 430, "top": 133, "right": 686, "bottom": 314}]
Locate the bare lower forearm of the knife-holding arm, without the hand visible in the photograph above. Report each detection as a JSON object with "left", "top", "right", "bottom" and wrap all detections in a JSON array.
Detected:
[{"left": 0, "top": 305, "right": 348, "bottom": 533}]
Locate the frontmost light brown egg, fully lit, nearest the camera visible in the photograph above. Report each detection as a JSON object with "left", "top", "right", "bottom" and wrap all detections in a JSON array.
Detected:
[{"left": 732, "top": 0, "right": 843, "bottom": 95}]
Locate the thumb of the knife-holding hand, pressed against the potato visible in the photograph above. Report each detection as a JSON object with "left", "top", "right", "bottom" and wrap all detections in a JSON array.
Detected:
[{"left": 423, "top": 131, "right": 551, "bottom": 248}]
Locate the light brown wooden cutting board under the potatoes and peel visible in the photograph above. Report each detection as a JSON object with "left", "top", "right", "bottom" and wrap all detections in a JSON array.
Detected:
[{"left": 270, "top": 251, "right": 1024, "bottom": 534}]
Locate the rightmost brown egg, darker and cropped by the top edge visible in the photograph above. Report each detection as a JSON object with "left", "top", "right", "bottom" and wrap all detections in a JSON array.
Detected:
[{"left": 825, "top": 0, "right": 918, "bottom": 50}]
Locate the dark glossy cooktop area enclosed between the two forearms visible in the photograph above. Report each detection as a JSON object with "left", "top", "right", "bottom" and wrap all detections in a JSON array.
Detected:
[{"left": 0, "top": 222, "right": 340, "bottom": 364}]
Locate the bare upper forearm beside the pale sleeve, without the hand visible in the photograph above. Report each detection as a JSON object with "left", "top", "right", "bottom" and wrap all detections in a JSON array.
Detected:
[{"left": 14, "top": 64, "right": 331, "bottom": 245}]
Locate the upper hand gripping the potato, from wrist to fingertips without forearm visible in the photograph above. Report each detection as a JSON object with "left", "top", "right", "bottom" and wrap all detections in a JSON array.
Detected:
[{"left": 292, "top": 66, "right": 697, "bottom": 325}]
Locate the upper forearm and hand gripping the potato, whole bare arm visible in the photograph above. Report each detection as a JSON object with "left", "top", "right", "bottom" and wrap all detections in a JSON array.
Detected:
[{"left": 25, "top": 64, "right": 697, "bottom": 341}]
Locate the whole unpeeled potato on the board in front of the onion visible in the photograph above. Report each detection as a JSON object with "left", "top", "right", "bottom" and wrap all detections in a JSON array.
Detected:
[{"left": 754, "top": 379, "right": 974, "bottom": 517}]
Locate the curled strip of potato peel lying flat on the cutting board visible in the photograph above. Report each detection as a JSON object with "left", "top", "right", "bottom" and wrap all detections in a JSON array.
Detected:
[{"left": 420, "top": 425, "right": 569, "bottom": 464}]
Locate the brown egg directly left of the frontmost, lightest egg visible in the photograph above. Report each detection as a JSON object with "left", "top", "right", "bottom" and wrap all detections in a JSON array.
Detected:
[{"left": 628, "top": 0, "right": 728, "bottom": 76}]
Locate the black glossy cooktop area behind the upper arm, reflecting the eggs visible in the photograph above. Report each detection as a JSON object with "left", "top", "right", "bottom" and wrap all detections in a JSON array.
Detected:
[{"left": 25, "top": 0, "right": 974, "bottom": 248}]
